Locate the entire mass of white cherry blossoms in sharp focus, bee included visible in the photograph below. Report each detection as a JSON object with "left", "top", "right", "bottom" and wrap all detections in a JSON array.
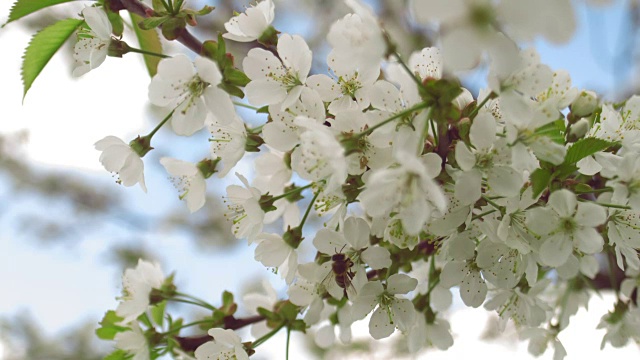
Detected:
[{"left": 42, "top": 0, "right": 640, "bottom": 360}]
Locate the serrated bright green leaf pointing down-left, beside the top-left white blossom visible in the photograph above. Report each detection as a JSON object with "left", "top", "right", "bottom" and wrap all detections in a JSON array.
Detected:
[{"left": 22, "top": 19, "right": 84, "bottom": 99}]
